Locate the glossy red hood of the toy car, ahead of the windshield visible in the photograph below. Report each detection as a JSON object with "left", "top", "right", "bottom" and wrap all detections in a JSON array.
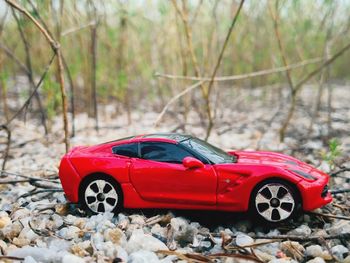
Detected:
[{"left": 230, "top": 151, "right": 328, "bottom": 178}]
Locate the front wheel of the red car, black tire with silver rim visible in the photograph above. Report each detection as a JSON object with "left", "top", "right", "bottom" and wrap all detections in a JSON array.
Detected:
[{"left": 250, "top": 179, "right": 300, "bottom": 224}]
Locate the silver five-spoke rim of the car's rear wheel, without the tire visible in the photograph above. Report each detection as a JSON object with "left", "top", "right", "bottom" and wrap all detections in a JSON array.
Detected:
[{"left": 84, "top": 179, "right": 118, "bottom": 213}]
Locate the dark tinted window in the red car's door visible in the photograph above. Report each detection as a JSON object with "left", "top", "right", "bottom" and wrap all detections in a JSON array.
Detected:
[{"left": 141, "top": 142, "right": 193, "bottom": 163}]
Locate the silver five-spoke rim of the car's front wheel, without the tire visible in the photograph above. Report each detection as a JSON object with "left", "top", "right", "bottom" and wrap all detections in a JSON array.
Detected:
[{"left": 255, "top": 183, "right": 295, "bottom": 222}]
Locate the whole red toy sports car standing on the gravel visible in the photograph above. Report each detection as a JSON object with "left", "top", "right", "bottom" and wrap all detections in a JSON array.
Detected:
[{"left": 59, "top": 133, "right": 332, "bottom": 222}]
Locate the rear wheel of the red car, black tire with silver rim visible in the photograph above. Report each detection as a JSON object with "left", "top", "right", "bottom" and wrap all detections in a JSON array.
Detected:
[{"left": 79, "top": 174, "right": 123, "bottom": 214}]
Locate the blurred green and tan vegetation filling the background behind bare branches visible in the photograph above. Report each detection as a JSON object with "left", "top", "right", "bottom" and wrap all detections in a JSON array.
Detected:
[{"left": 0, "top": 0, "right": 350, "bottom": 137}]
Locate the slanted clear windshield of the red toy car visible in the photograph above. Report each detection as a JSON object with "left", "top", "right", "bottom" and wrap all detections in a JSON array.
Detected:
[{"left": 181, "top": 138, "right": 236, "bottom": 164}]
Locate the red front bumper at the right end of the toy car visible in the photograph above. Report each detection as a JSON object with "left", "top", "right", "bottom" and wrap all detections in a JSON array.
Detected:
[{"left": 298, "top": 176, "right": 332, "bottom": 211}]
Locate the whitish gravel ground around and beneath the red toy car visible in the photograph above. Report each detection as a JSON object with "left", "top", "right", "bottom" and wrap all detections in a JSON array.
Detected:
[{"left": 0, "top": 86, "right": 350, "bottom": 263}]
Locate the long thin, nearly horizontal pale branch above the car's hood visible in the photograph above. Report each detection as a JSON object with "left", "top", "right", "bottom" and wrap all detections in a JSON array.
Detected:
[{"left": 154, "top": 57, "right": 323, "bottom": 81}]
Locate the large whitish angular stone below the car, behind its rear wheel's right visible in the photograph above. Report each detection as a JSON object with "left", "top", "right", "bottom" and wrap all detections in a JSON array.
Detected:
[{"left": 126, "top": 229, "right": 168, "bottom": 253}]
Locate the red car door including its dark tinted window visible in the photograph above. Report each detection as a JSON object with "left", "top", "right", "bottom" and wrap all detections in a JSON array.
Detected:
[{"left": 130, "top": 142, "right": 217, "bottom": 205}]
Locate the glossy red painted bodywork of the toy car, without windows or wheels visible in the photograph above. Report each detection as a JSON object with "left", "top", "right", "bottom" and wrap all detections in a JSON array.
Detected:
[{"left": 59, "top": 135, "right": 332, "bottom": 211}]
